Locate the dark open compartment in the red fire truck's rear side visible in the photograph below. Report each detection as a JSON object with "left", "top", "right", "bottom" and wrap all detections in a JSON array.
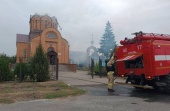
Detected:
[{"left": 124, "top": 56, "right": 144, "bottom": 69}]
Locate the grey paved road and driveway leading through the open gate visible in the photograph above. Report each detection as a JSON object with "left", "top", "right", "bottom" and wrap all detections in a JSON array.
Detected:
[{"left": 0, "top": 71, "right": 170, "bottom": 111}]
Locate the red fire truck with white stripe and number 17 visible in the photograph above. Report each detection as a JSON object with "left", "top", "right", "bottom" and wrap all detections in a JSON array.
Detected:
[{"left": 116, "top": 31, "right": 170, "bottom": 91}]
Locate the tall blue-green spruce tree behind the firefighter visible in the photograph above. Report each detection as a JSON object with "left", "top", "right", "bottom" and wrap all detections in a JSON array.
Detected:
[{"left": 99, "top": 21, "right": 116, "bottom": 58}]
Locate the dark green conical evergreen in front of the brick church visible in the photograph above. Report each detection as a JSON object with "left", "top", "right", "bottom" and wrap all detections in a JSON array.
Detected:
[{"left": 30, "top": 45, "right": 49, "bottom": 82}]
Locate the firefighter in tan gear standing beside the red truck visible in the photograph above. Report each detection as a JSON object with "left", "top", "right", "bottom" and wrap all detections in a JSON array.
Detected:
[{"left": 106, "top": 53, "right": 115, "bottom": 92}]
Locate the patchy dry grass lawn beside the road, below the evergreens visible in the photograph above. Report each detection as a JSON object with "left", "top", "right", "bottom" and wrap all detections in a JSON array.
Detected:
[{"left": 0, "top": 81, "right": 86, "bottom": 104}]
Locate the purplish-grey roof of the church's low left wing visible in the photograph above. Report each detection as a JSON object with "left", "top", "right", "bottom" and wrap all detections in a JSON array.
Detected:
[{"left": 16, "top": 34, "right": 30, "bottom": 42}]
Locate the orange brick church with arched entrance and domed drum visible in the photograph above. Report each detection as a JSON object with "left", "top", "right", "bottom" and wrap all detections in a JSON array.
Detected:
[{"left": 16, "top": 14, "right": 69, "bottom": 64}]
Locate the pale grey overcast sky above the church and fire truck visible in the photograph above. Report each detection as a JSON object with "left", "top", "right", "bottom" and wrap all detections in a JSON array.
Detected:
[{"left": 0, "top": 0, "right": 170, "bottom": 56}]
